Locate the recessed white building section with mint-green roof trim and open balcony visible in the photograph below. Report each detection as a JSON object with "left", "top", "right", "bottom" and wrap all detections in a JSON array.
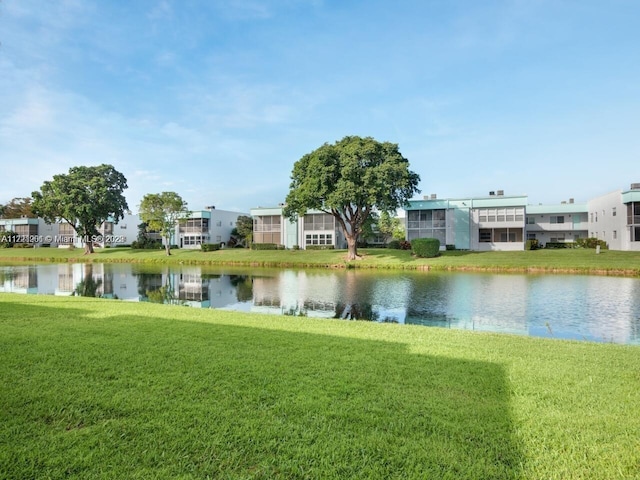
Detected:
[{"left": 526, "top": 203, "right": 589, "bottom": 246}]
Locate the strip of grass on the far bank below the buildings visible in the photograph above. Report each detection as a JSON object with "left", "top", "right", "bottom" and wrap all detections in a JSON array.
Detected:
[{"left": 0, "top": 248, "right": 640, "bottom": 276}]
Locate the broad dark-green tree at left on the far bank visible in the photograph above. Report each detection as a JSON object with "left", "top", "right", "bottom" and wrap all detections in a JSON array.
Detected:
[{"left": 31, "top": 164, "right": 129, "bottom": 254}]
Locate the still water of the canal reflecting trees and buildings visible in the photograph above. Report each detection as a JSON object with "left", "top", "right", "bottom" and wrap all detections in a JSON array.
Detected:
[{"left": 0, "top": 264, "right": 640, "bottom": 344}]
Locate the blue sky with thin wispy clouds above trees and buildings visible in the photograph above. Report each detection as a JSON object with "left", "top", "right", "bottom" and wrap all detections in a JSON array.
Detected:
[{"left": 0, "top": 0, "right": 640, "bottom": 212}]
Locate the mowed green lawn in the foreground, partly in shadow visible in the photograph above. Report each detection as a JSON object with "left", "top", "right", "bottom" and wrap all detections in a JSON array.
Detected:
[{"left": 0, "top": 294, "right": 640, "bottom": 479}]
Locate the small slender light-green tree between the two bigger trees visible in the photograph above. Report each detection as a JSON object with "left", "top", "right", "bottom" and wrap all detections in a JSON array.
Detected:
[{"left": 140, "top": 192, "right": 189, "bottom": 255}]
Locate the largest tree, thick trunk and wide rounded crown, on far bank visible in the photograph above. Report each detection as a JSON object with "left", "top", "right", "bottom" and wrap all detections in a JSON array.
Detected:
[{"left": 284, "top": 136, "right": 420, "bottom": 260}]
